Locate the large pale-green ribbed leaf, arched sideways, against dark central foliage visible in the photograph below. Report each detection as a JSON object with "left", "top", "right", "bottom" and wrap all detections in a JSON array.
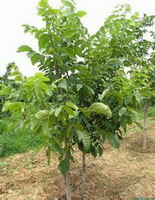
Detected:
[{"left": 89, "top": 103, "right": 112, "bottom": 117}]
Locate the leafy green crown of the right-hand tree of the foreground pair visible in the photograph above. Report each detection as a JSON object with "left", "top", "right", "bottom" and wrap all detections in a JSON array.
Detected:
[{"left": 75, "top": 5, "right": 153, "bottom": 194}]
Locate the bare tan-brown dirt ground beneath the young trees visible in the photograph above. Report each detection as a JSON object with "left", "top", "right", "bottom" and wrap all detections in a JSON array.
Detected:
[{"left": 0, "top": 118, "right": 155, "bottom": 200}]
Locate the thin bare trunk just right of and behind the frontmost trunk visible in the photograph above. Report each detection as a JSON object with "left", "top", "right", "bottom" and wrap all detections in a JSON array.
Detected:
[{"left": 82, "top": 152, "right": 86, "bottom": 197}]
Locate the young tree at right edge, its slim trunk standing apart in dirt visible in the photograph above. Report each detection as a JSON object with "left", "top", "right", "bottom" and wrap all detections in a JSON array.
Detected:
[{"left": 130, "top": 15, "right": 155, "bottom": 151}]
